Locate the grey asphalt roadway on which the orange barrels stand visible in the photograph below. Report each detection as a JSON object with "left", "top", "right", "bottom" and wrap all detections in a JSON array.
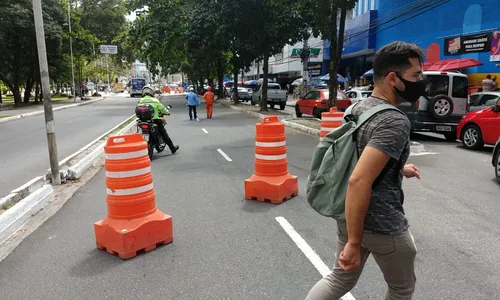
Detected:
[{"left": 0, "top": 97, "right": 500, "bottom": 300}]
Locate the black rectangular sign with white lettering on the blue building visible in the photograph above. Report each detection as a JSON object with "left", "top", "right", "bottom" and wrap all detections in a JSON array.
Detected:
[{"left": 444, "top": 32, "right": 492, "bottom": 55}]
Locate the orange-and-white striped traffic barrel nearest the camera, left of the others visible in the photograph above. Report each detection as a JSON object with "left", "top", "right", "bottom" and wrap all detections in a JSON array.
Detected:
[{"left": 94, "top": 133, "right": 173, "bottom": 259}]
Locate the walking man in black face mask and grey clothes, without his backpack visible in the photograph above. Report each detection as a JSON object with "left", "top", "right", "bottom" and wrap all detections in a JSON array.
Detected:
[{"left": 306, "top": 42, "right": 426, "bottom": 300}]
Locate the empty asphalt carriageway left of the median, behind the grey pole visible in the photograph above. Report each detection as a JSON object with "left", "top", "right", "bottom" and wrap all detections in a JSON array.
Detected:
[{"left": 0, "top": 94, "right": 138, "bottom": 197}]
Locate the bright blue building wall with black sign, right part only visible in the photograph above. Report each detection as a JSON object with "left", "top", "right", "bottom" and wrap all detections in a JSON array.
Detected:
[{"left": 376, "top": 0, "right": 500, "bottom": 85}]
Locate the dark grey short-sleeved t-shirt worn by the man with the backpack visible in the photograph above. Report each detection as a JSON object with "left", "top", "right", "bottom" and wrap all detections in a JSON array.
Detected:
[{"left": 352, "top": 97, "right": 411, "bottom": 234}]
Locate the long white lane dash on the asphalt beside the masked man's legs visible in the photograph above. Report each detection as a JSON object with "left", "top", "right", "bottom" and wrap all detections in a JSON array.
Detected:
[{"left": 276, "top": 217, "right": 356, "bottom": 300}]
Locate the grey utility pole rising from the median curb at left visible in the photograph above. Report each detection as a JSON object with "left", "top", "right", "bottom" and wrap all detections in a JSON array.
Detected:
[{"left": 33, "top": 0, "right": 61, "bottom": 185}]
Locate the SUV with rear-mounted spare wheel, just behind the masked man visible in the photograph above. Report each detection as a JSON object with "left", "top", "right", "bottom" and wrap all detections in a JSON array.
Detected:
[{"left": 398, "top": 71, "right": 469, "bottom": 141}]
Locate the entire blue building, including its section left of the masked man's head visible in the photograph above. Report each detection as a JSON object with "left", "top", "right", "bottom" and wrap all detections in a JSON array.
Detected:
[{"left": 323, "top": 0, "right": 500, "bottom": 85}]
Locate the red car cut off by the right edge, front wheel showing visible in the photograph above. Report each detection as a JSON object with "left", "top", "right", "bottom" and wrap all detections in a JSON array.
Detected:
[{"left": 457, "top": 100, "right": 500, "bottom": 149}]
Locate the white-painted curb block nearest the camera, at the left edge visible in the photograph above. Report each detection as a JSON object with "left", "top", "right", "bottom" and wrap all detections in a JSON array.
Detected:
[{"left": 0, "top": 184, "right": 54, "bottom": 245}]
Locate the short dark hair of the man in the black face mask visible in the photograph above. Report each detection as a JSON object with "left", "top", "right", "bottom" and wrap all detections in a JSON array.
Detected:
[{"left": 373, "top": 42, "right": 424, "bottom": 81}]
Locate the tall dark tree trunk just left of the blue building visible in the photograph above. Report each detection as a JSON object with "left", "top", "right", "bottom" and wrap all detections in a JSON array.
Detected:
[{"left": 328, "top": 3, "right": 345, "bottom": 109}]
